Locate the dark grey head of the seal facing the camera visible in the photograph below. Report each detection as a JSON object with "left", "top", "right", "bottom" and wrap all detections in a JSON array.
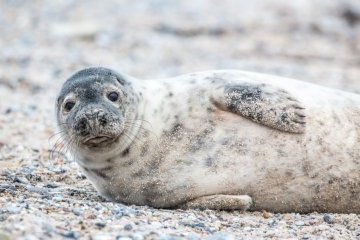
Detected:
[{"left": 56, "top": 67, "right": 137, "bottom": 151}]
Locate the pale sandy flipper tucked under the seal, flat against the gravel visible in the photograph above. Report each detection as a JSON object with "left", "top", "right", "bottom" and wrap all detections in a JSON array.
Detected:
[{"left": 180, "top": 195, "right": 252, "bottom": 211}]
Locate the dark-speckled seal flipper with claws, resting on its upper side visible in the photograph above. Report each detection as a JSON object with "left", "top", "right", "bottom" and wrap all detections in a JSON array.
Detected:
[{"left": 211, "top": 83, "right": 306, "bottom": 133}]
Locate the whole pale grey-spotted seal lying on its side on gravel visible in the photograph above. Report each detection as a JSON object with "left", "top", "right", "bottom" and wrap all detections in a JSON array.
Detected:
[{"left": 56, "top": 67, "right": 360, "bottom": 213}]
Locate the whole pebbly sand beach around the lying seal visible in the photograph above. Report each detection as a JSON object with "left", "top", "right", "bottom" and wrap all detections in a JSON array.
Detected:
[{"left": 0, "top": 0, "right": 360, "bottom": 240}]
